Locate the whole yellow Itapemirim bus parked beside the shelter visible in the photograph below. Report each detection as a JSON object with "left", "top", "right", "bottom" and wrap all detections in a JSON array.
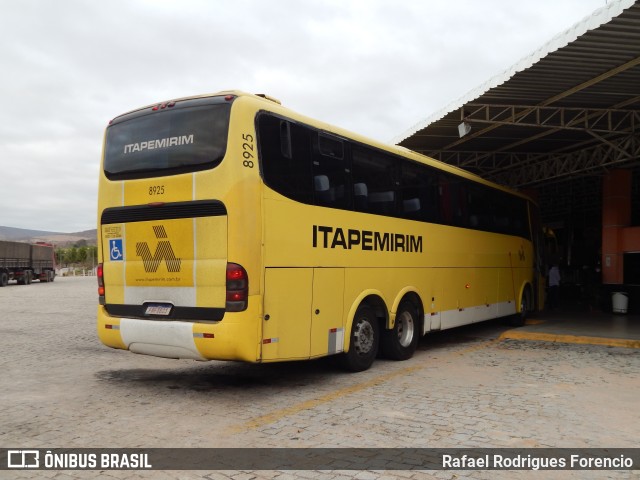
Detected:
[{"left": 97, "top": 91, "right": 542, "bottom": 371}]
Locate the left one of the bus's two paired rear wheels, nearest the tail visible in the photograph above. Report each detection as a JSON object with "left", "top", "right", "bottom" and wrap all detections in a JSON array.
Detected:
[{"left": 340, "top": 304, "right": 380, "bottom": 372}]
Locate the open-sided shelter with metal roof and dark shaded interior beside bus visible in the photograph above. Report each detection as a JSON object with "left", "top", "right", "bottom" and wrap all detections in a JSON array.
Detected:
[{"left": 395, "top": 0, "right": 640, "bottom": 312}]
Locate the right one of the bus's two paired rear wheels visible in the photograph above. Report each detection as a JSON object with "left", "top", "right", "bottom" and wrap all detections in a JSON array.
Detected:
[{"left": 381, "top": 300, "right": 419, "bottom": 360}]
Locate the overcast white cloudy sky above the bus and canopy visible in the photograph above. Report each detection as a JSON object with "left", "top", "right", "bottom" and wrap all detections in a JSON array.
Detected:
[{"left": 0, "top": 0, "right": 604, "bottom": 232}]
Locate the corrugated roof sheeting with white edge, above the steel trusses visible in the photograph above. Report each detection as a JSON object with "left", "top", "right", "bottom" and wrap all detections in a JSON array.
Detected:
[{"left": 393, "top": 0, "right": 640, "bottom": 146}]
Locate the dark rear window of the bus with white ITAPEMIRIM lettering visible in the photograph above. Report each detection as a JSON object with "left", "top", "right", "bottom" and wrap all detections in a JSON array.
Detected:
[{"left": 104, "top": 104, "right": 230, "bottom": 180}]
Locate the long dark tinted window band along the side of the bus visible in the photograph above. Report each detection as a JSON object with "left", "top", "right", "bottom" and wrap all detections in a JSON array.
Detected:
[{"left": 257, "top": 113, "right": 530, "bottom": 238}]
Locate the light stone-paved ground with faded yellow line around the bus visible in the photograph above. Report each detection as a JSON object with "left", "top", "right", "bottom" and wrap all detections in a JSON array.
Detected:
[{"left": 0, "top": 278, "right": 640, "bottom": 480}]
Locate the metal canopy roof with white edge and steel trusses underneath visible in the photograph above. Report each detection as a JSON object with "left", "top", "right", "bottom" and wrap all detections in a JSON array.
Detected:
[{"left": 395, "top": 0, "right": 640, "bottom": 223}]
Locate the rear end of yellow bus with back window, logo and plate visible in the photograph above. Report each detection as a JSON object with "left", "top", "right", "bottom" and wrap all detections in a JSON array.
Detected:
[{"left": 98, "top": 94, "right": 259, "bottom": 361}]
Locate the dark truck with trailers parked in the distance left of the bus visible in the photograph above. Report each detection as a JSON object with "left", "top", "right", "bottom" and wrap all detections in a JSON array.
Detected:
[{"left": 0, "top": 241, "right": 56, "bottom": 287}]
